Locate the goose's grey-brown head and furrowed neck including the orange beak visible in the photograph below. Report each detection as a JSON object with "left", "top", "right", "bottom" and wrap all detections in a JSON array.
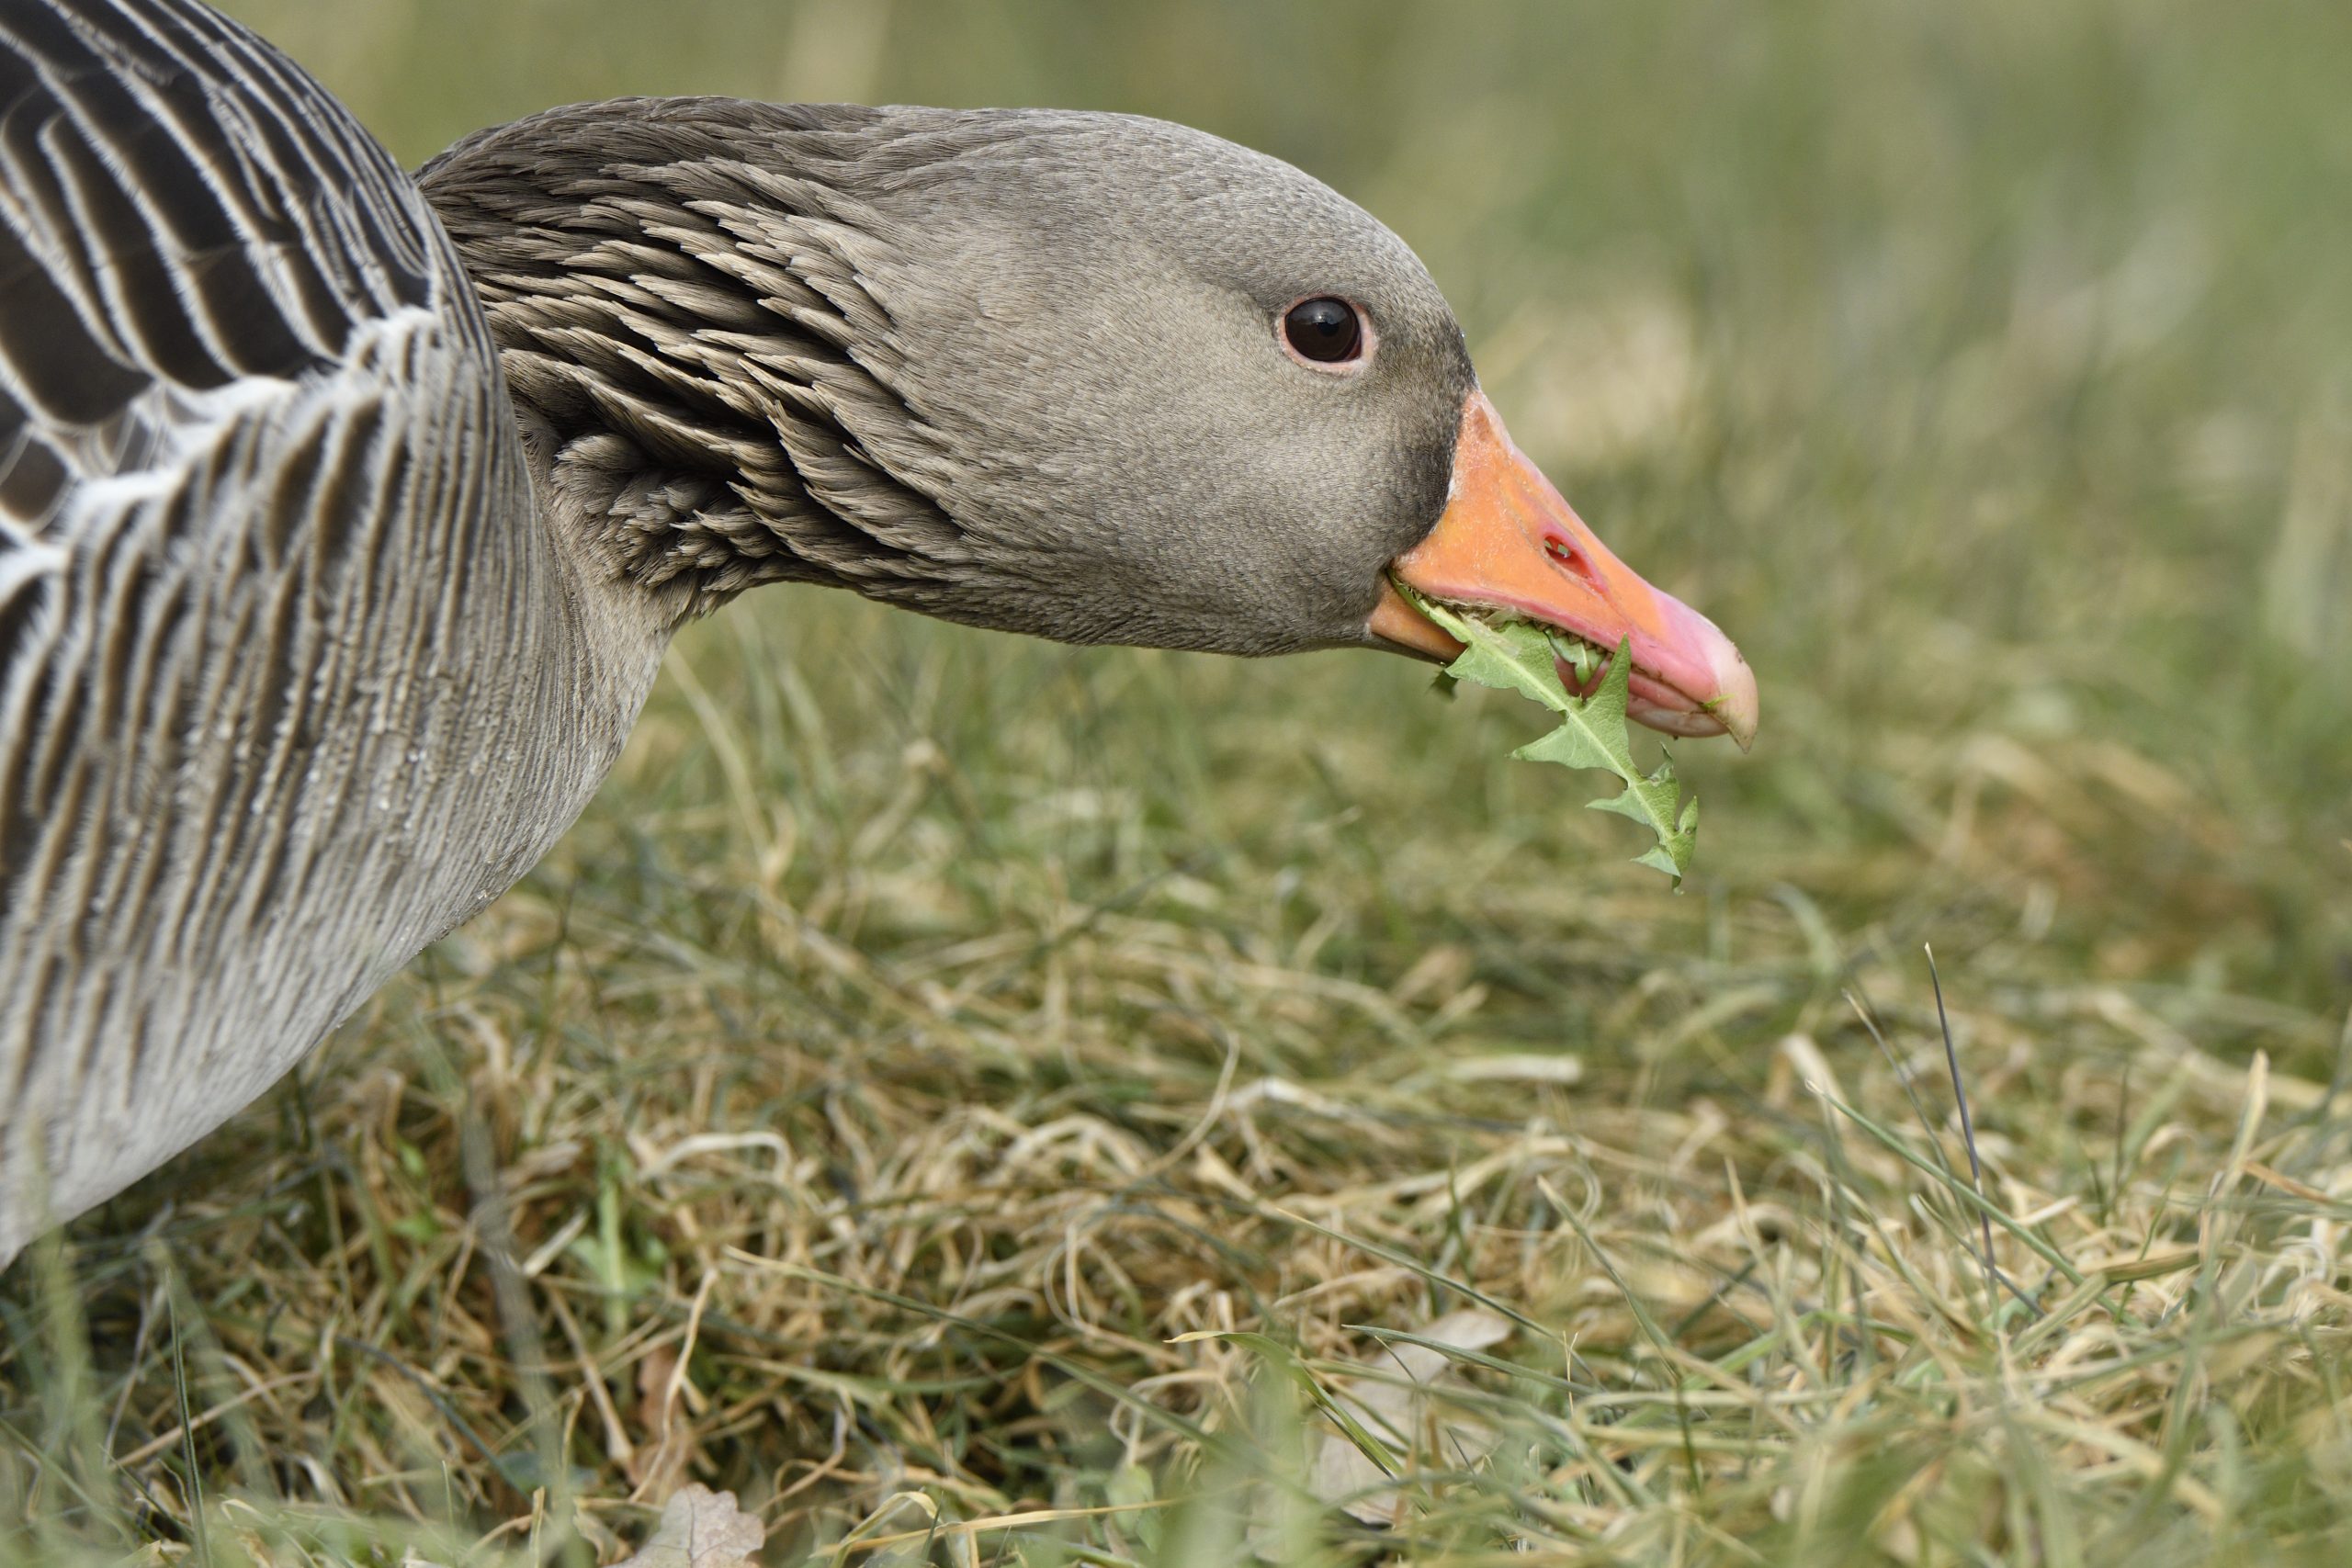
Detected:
[{"left": 421, "top": 98, "right": 1757, "bottom": 745}]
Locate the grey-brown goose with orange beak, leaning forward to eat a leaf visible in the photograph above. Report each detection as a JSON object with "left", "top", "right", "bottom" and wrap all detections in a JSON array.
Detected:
[{"left": 0, "top": 0, "right": 1757, "bottom": 1265}]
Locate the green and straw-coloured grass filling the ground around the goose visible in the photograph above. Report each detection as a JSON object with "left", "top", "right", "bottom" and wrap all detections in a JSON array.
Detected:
[{"left": 0, "top": 0, "right": 2352, "bottom": 1568}]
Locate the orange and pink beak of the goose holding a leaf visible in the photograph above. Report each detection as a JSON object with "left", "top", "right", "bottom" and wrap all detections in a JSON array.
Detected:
[{"left": 1364, "top": 392, "right": 1757, "bottom": 750}]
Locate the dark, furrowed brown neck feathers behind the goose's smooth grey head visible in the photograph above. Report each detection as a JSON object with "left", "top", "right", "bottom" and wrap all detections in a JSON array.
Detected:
[{"left": 419, "top": 98, "right": 971, "bottom": 618}]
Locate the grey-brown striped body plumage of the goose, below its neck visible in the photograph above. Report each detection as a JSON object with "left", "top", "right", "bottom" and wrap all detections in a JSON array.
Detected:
[{"left": 0, "top": 0, "right": 659, "bottom": 1265}]
